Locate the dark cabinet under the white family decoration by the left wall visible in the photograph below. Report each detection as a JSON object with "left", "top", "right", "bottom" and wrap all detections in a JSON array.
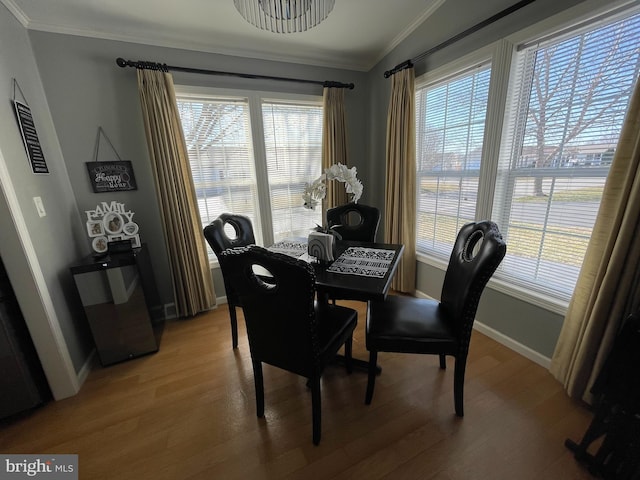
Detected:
[{"left": 71, "top": 244, "right": 164, "bottom": 366}]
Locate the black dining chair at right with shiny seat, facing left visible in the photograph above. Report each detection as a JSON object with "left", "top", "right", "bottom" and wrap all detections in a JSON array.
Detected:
[{"left": 365, "top": 221, "right": 507, "bottom": 417}]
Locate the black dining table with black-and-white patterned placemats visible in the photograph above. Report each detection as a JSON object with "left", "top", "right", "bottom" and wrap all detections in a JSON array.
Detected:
[{"left": 268, "top": 238, "right": 404, "bottom": 373}]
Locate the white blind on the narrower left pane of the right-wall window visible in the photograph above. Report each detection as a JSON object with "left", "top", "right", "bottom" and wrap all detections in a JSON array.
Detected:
[{"left": 416, "top": 63, "right": 491, "bottom": 259}]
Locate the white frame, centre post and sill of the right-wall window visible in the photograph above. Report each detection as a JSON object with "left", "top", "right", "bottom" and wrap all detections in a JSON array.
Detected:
[{"left": 416, "top": 0, "right": 640, "bottom": 315}]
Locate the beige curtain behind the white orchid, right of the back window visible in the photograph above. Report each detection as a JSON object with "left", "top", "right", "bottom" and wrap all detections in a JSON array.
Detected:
[{"left": 322, "top": 87, "right": 349, "bottom": 211}]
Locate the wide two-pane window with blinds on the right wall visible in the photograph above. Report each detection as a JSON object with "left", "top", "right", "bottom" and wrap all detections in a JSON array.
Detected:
[{"left": 416, "top": 3, "right": 640, "bottom": 302}]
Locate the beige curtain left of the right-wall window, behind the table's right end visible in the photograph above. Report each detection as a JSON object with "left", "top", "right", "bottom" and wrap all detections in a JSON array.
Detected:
[{"left": 384, "top": 67, "right": 416, "bottom": 293}]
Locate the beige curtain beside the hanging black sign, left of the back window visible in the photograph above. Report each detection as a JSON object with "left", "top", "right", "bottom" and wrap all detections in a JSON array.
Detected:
[{"left": 138, "top": 66, "right": 216, "bottom": 317}]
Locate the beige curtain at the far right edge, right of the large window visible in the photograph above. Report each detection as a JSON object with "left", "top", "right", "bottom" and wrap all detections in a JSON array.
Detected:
[{"left": 550, "top": 78, "right": 640, "bottom": 403}]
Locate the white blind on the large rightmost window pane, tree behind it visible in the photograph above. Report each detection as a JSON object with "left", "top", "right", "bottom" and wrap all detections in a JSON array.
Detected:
[{"left": 493, "top": 9, "right": 640, "bottom": 300}]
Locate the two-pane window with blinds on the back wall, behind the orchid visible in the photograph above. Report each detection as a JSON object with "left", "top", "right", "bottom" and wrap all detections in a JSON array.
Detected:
[{"left": 176, "top": 87, "right": 323, "bottom": 260}]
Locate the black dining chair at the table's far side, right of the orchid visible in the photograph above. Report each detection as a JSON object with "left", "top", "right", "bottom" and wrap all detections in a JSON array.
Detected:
[{"left": 327, "top": 202, "right": 380, "bottom": 242}]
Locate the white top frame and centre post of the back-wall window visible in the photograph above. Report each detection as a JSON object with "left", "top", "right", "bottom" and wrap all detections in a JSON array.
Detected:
[{"left": 174, "top": 85, "right": 322, "bottom": 266}]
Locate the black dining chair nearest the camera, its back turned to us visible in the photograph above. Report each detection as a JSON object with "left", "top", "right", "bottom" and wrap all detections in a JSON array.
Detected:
[{"left": 220, "top": 245, "right": 358, "bottom": 445}]
